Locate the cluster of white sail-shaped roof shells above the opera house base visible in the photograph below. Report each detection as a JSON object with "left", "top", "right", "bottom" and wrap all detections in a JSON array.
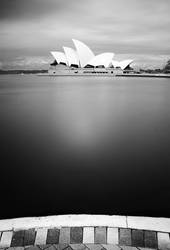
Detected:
[{"left": 51, "top": 39, "right": 133, "bottom": 73}]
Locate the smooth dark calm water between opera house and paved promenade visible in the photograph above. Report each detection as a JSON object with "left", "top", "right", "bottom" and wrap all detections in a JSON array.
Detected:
[{"left": 0, "top": 75, "right": 170, "bottom": 218}]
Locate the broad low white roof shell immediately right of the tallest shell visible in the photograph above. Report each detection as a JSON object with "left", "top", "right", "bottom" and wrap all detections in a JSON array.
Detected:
[{"left": 87, "top": 53, "right": 114, "bottom": 68}]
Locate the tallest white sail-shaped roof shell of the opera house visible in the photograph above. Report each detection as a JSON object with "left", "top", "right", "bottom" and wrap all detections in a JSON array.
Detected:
[{"left": 72, "top": 39, "right": 95, "bottom": 67}]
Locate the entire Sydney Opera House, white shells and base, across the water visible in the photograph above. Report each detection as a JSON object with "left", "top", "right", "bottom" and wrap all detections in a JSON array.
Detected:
[{"left": 49, "top": 39, "right": 133, "bottom": 75}]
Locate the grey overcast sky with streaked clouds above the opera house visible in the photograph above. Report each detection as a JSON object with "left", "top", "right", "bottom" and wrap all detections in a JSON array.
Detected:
[{"left": 0, "top": 0, "right": 170, "bottom": 66}]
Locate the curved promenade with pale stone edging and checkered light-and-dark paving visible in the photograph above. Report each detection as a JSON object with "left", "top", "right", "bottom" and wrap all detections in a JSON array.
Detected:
[{"left": 0, "top": 215, "right": 170, "bottom": 250}]
